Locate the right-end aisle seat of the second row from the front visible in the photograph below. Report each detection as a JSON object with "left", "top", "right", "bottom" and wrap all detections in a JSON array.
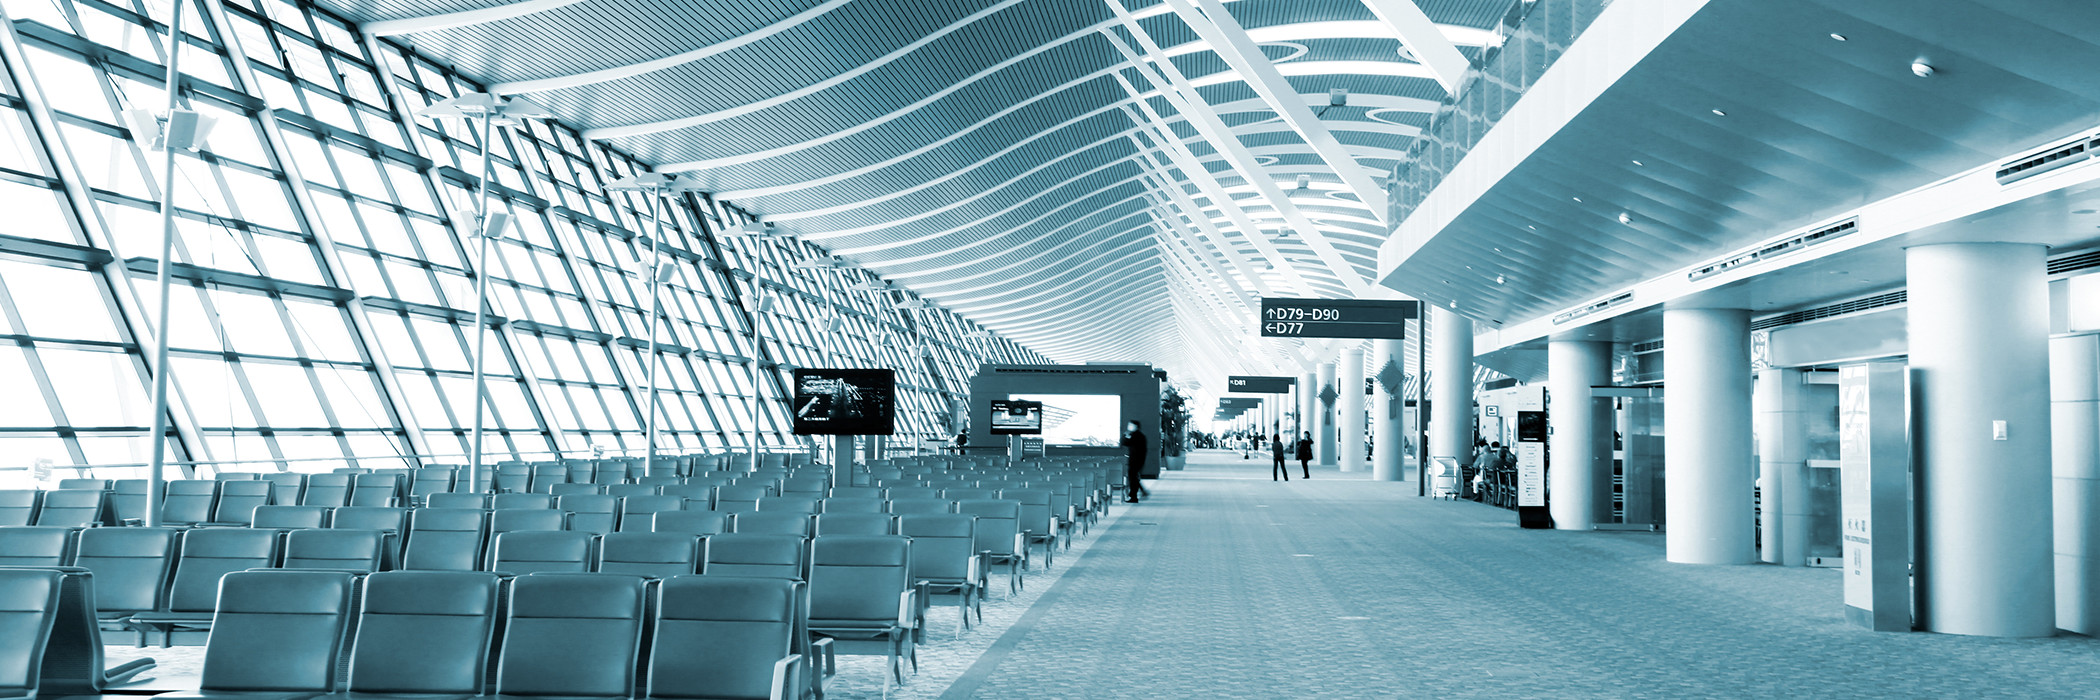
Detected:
[{"left": 809, "top": 534, "right": 920, "bottom": 681}]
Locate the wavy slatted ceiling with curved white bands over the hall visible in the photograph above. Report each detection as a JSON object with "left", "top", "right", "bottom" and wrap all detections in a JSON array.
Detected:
[{"left": 334, "top": 0, "right": 1512, "bottom": 376}]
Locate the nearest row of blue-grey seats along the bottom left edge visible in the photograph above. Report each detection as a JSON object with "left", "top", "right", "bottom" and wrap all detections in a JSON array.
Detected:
[{"left": 0, "top": 567, "right": 827, "bottom": 700}]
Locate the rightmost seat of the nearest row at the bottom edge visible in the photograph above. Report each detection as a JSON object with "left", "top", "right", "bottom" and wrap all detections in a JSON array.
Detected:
[{"left": 647, "top": 576, "right": 806, "bottom": 700}]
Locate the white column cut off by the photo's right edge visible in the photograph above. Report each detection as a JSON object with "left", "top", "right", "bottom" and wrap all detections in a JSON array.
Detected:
[{"left": 2050, "top": 334, "right": 2100, "bottom": 635}]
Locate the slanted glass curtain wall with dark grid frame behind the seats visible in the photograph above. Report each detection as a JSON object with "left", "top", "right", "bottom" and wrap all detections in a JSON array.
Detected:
[{"left": 0, "top": 0, "right": 1046, "bottom": 481}]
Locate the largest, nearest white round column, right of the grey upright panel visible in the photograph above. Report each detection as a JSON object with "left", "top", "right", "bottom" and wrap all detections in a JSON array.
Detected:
[{"left": 1915, "top": 244, "right": 2056, "bottom": 637}]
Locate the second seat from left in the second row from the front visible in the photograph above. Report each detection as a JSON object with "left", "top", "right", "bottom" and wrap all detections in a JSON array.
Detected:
[{"left": 74, "top": 528, "right": 179, "bottom": 620}]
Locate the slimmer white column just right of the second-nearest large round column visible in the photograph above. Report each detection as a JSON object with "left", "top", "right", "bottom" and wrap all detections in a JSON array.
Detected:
[{"left": 1755, "top": 367, "right": 1810, "bottom": 565}]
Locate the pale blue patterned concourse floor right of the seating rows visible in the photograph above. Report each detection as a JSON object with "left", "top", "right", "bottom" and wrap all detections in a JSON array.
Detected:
[{"left": 113, "top": 452, "right": 2100, "bottom": 700}]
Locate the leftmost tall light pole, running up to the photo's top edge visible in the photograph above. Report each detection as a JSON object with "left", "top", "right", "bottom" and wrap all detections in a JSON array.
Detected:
[{"left": 124, "top": 0, "right": 212, "bottom": 528}]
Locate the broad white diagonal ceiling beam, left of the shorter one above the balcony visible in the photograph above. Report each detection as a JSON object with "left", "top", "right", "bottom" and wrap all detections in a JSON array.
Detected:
[{"left": 1166, "top": 0, "right": 1394, "bottom": 223}]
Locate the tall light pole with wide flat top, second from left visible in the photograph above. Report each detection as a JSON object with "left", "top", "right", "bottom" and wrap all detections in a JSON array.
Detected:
[{"left": 416, "top": 92, "right": 554, "bottom": 492}]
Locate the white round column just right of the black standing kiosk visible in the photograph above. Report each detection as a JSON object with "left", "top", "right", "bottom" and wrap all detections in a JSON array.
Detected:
[{"left": 1546, "top": 341, "right": 1611, "bottom": 530}]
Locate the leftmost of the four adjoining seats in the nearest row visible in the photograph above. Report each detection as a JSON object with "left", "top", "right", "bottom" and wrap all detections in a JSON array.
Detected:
[{"left": 160, "top": 570, "right": 355, "bottom": 700}]
